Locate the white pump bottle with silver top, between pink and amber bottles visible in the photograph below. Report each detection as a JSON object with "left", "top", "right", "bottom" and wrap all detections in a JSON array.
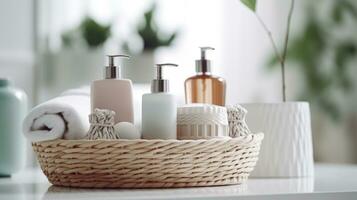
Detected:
[{"left": 142, "top": 63, "right": 177, "bottom": 140}]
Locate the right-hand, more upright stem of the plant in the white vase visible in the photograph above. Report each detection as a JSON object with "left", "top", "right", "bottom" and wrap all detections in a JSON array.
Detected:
[{"left": 281, "top": 0, "right": 295, "bottom": 102}]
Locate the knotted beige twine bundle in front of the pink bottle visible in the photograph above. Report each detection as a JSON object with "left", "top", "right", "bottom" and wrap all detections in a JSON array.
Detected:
[{"left": 87, "top": 108, "right": 119, "bottom": 140}]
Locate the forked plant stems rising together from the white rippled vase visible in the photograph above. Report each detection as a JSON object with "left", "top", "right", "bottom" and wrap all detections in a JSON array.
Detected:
[{"left": 240, "top": 0, "right": 295, "bottom": 102}]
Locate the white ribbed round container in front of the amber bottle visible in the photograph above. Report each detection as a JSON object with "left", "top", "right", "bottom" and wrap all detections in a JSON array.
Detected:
[{"left": 177, "top": 104, "right": 229, "bottom": 140}]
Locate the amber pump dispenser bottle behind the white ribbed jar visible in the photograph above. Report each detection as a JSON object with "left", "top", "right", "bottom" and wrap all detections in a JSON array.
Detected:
[{"left": 185, "top": 47, "right": 226, "bottom": 106}]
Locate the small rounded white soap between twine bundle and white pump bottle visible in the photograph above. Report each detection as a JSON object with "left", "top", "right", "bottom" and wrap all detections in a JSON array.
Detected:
[{"left": 114, "top": 122, "right": 141, "bottom": 139}]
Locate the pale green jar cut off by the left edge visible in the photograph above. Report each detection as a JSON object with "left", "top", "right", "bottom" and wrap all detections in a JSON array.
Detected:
[{"left": 0, "top": 78, "right": 27, "bottom": 177}]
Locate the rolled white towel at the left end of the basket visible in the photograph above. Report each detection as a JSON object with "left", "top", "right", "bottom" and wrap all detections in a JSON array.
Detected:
[{"left": 23, "top": 87, "right": 90, "bottom": 142}]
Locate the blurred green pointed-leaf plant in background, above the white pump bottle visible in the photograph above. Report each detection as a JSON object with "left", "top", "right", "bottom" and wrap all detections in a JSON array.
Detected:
[{"left": 124, "top": 4, "right": 178, "bottom": 51}]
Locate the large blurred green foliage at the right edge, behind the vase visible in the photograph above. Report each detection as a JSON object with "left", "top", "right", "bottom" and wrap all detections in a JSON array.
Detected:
[{"left": 269, "top": 0, "right": 357, "bottom": 120}]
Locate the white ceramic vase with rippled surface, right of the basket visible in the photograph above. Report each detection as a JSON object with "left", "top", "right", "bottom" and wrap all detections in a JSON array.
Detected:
[{"left": 242, "top": 102, "right": 314, "bottom": 177}]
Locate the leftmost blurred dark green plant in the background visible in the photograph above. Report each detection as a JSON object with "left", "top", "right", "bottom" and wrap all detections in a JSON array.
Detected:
[{"left": 61, "top": 17, "right": 111, "bottom": 48}]
